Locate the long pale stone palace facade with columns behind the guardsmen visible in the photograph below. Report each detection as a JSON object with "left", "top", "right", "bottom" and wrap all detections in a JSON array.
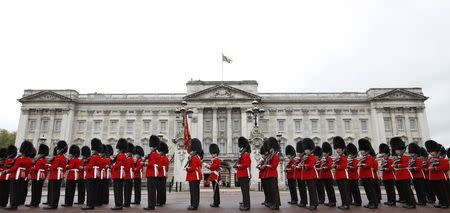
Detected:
[{"left": 16, "top": 81, "right": 430, "bottom": 186}]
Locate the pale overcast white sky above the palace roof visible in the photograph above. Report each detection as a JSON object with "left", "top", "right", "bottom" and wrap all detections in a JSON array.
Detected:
[{"left": 0, "top": 0, "right": 450, "bottom": 145}]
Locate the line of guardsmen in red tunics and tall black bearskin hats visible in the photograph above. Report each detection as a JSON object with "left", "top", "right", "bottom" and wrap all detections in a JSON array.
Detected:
[{"left": 0, "top": 135, "right": 450, "bottom": 211}]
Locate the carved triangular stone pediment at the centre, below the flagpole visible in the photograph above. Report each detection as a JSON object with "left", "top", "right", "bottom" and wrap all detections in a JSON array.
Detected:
[{"left": 184, "top": 84, "right": 261, "bottom": 100}]
